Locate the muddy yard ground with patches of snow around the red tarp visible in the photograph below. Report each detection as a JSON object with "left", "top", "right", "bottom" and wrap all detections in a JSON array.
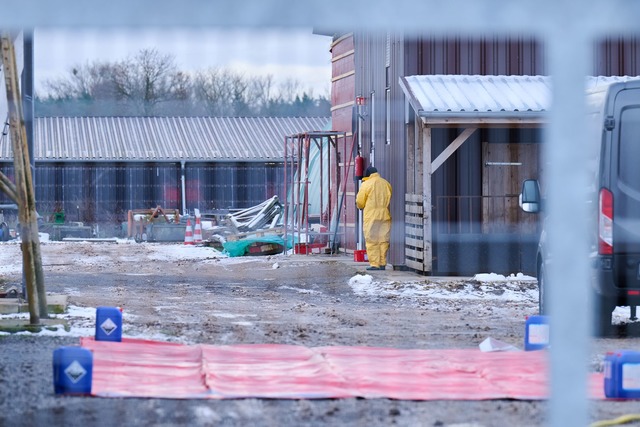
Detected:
[{"left": 0, "top": 242, "right": 640, "bottom": 426}]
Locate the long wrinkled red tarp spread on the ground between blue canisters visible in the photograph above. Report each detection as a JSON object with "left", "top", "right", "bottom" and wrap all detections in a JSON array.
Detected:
[{"left": 81, "top": 338, "right": 605, "bottom": 400}]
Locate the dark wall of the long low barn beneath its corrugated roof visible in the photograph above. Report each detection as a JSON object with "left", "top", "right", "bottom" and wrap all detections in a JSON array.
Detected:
[{"left": 0, "top": 162, "right": 284, "bottom": 224}]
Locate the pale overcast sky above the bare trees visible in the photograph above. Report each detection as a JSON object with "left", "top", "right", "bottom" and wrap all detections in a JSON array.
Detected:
[{"left": 34, "top": 29, "right": 331, "bottom": 97}]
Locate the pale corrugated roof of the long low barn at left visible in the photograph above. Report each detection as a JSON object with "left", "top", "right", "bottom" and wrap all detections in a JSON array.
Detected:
[{"left": 15, "top": 117, "right": 329, "bottom": 162}]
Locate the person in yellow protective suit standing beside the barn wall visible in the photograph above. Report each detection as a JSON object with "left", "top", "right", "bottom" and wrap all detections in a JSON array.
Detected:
[{"left": 356, "top": 166, "right": 391, "bottom": 270}]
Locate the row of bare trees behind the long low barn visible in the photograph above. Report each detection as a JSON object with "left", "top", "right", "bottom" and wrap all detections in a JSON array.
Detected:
[{"left": 36, "top": 49, "right": 329, "bottom": 117}]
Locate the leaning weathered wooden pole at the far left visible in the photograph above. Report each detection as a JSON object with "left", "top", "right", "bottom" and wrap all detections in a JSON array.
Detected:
[{"left": 0, "top": 32, "right": 49, "bottom": 325}]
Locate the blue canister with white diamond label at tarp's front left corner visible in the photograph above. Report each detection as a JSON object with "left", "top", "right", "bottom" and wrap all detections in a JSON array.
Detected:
[{"left": 53, "top": 347, "right": 93, "bottom": 394}]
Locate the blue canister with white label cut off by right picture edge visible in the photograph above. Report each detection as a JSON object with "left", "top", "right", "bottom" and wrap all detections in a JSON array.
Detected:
[{"left": 604, "top": 350, "right": 640, "bottom": 399}]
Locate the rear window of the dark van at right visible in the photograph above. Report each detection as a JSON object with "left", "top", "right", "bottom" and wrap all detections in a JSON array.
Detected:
[{"left": 618, "top": 106, "right": 640, "bottom": 191}]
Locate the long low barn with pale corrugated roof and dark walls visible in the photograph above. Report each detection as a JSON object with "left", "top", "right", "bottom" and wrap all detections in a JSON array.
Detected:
[{"left": 0, "top": 117, "right": 329, "bottom": 229}]
